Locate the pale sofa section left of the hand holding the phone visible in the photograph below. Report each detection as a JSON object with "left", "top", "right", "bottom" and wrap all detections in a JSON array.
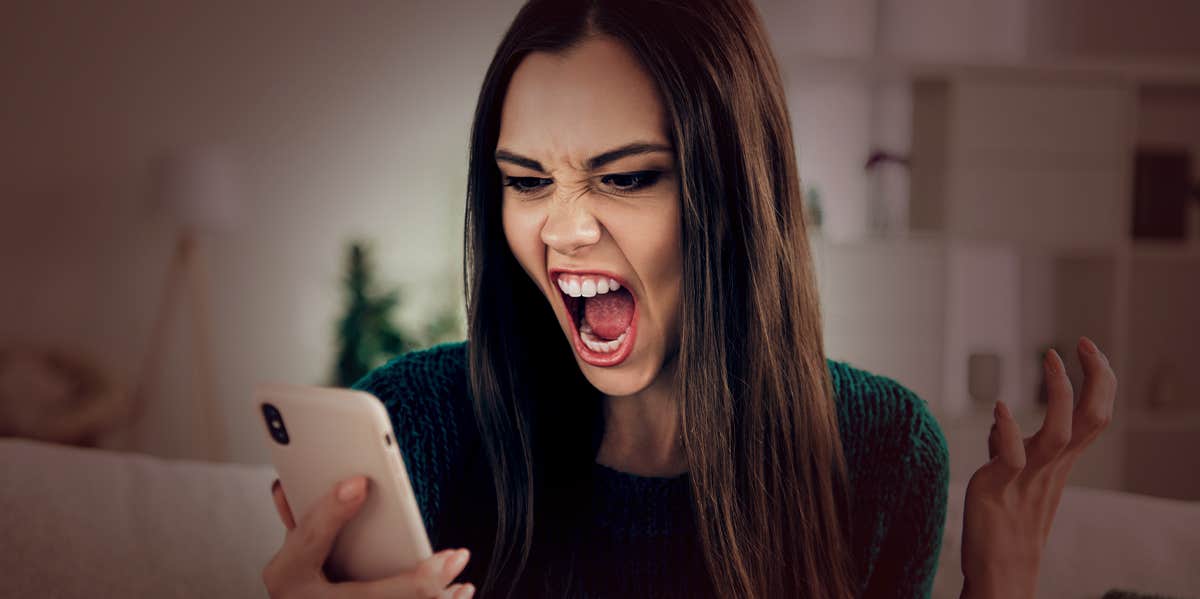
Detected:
[{"left": 0, "top": 438, "right": 283, "bottom": 598}]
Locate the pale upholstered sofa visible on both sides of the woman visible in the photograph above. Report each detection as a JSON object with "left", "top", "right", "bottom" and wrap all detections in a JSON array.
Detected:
[{"left": 0, "top": 438, "right": 1200, "bottom": 599}]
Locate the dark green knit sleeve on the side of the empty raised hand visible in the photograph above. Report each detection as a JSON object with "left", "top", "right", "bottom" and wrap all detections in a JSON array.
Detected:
[{"left": 864, "top": 377, "right": 949, "bottom": 598}]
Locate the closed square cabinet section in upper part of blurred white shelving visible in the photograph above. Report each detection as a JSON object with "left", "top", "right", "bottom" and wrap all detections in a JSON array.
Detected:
[{"left": 911, "top": 74, "right": 1135, "bottom": 248}]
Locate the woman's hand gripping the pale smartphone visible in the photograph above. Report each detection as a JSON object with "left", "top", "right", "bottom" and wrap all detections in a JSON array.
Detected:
[{"left": 263, "top": 477, "right": 475, "bottom": 599}]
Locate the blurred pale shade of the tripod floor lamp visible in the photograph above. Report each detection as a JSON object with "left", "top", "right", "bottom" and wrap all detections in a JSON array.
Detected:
[{"left": 156, "top": 145, "right": 246, "bottom": 233}]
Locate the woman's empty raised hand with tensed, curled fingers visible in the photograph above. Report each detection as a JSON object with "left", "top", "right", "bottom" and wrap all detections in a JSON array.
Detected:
[{"left": 962, "top": 337, "right": 1117, "bottom": 599}]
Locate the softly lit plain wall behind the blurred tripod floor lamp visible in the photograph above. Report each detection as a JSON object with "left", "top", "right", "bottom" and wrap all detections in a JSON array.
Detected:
[{"left": 0, "top": 0, "right": 518, "bottom": 462}]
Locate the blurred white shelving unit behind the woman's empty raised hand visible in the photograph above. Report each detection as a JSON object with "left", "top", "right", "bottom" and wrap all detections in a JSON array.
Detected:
[{"left": 782, "top": 35, "right": 1200, "bottom": 499}]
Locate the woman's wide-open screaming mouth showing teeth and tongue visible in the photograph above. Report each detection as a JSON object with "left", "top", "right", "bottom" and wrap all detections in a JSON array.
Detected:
[{"left": 550, "top": 270, "right": 637, "bottom": 366}]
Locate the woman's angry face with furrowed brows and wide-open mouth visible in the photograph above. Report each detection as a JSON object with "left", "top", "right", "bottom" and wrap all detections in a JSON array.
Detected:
[{"left": 496, "top": 36, "right": 683, "bottom": 396}]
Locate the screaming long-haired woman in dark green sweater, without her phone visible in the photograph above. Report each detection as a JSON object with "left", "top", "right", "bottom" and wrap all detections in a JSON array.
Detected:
[{"left": 264, "top": 0, "right": 1116, "bottom": 598}]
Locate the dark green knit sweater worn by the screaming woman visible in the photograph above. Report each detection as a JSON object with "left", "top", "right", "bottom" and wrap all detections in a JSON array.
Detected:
[{"left": 354, "top": 342, "right": 949, "bottom": 598}]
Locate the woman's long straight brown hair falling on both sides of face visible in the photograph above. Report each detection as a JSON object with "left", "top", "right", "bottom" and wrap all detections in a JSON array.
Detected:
[{"left": 463, "top": 0, "right": 856, "bottom": 598}]
